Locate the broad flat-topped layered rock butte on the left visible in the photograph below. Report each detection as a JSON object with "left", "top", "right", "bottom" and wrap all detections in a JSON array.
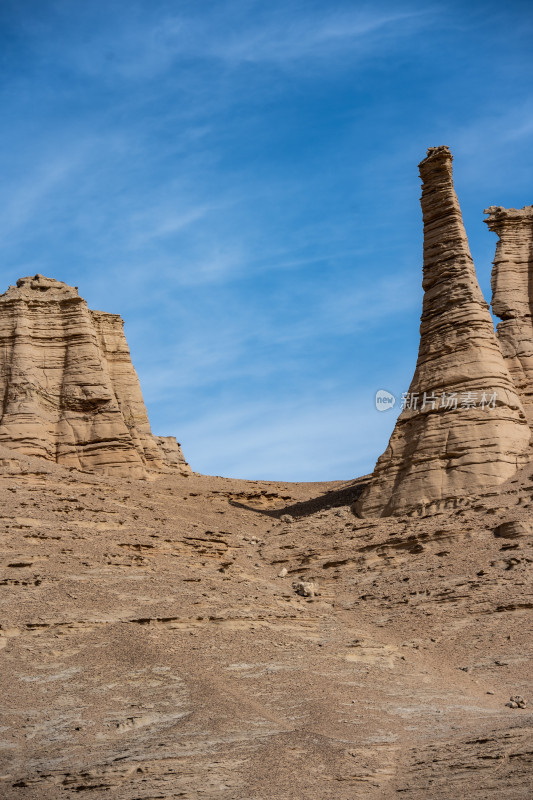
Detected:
[{"left": 0, "top": 275, "right": 188, "bottom": 478}]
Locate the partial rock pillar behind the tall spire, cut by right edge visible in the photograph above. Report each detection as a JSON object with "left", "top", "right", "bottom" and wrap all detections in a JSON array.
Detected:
[{"left": 485, "top": 206, "right": 533, "bottom": 427}]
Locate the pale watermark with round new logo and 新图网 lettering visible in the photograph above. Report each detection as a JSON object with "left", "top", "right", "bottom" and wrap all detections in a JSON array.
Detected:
[{"left": 374, "top": 389, "right": 498, "bottom": 411}]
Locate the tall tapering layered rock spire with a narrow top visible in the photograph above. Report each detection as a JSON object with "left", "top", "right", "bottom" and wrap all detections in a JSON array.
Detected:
[{"left": 357, "top": 147, "right": 530, "bottom": 516}]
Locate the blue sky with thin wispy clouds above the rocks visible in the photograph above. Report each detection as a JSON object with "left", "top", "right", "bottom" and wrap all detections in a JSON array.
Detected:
[{"left": 0, "top": 0, "right": 533, "bottom": 480}]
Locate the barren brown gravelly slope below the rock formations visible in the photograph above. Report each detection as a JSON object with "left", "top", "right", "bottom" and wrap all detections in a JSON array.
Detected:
[{"left": 0, "top": 449, "right": 533, "bottom": 800}]
